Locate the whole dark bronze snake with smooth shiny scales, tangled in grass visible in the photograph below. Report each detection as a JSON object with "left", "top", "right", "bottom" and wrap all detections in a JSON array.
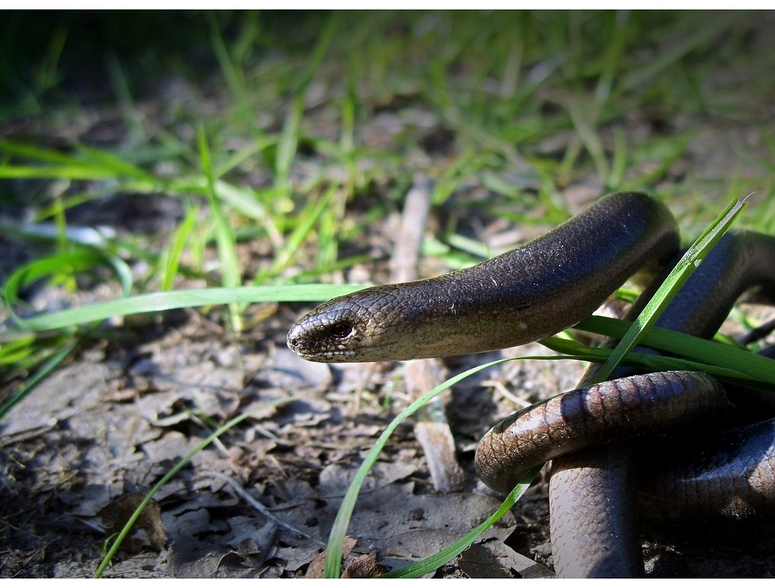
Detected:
[{"left": 287, "top": 192, "right": 775, "bottom": 577}]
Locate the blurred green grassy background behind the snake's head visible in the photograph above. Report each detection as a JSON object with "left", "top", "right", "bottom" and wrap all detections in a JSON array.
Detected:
[{"left": 0, "top": 11, "right": 775, "bottom": 382}]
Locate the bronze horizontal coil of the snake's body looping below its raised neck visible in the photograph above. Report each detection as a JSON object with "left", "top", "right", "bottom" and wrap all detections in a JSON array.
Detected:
[{"left": 476, "top": 371, "right": 728, "bottom": 492}]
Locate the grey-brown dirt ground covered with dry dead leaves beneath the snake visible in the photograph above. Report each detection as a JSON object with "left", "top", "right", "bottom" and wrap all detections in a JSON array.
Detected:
[{"left": 0, "top": 11, "right": 775, "bottom": 578}]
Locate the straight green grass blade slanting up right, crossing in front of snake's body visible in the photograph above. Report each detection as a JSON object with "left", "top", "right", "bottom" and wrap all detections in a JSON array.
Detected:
[{"left": 592, "top": 195, "right": 745, "bottom": 383}]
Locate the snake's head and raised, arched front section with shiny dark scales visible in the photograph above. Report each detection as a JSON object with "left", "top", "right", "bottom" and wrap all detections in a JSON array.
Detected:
[{"left": 288, "top": 193, "right": 678, "bottom": 362}]
